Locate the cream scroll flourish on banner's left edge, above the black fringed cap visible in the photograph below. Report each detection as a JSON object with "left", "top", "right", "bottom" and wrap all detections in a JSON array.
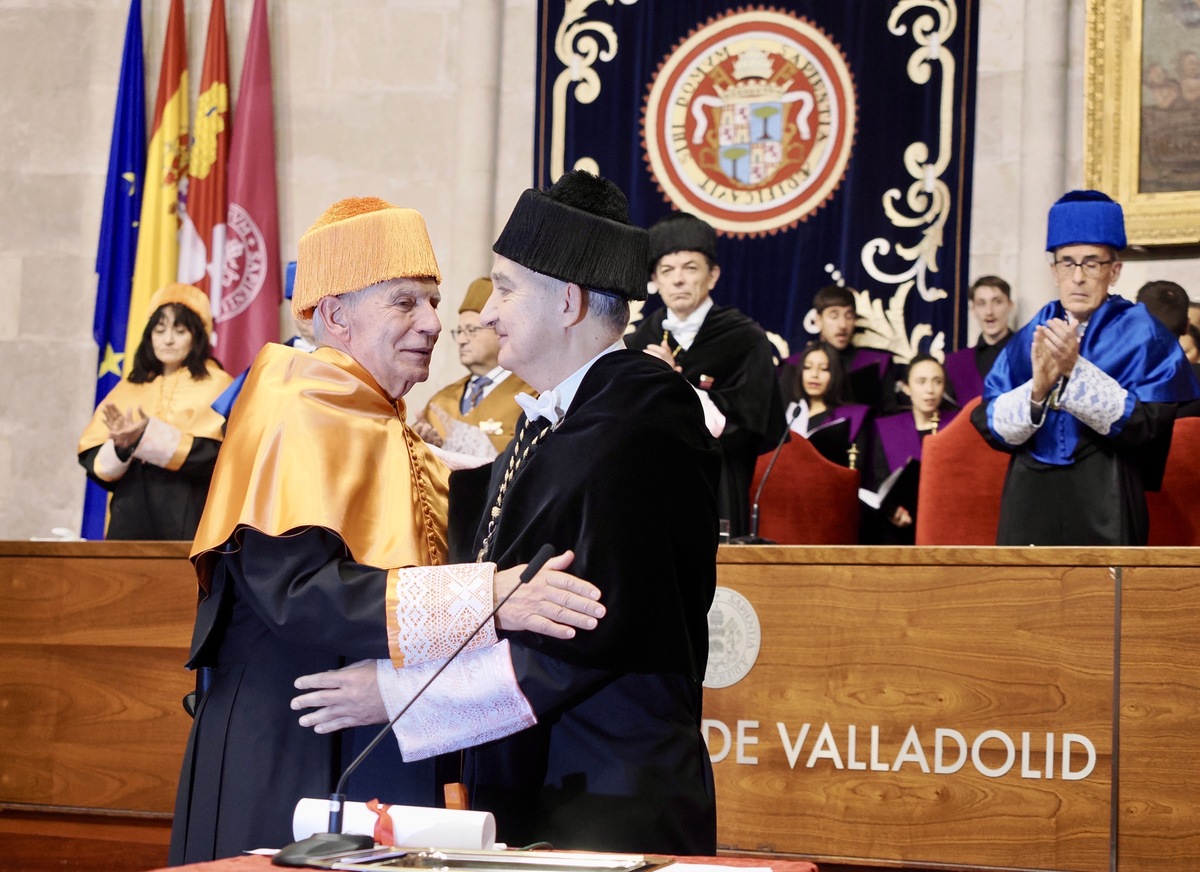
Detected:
[{"left": 550, "top": 0, "right": 637, "bottom": 179}]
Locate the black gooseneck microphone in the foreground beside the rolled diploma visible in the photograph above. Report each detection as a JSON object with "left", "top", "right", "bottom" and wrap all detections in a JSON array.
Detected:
[{"left": 271, "top": 543, "right": 554, "bottom": 868}]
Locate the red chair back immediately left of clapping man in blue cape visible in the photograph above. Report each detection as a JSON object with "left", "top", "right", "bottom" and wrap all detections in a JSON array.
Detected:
[{"left": 917, "top": 397, "right": 1009, "bottom": 545}]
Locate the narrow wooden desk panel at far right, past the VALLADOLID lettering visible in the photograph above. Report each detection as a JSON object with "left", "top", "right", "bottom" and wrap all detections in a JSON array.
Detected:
[{"left": 1117, "top": 567, "right": 1200, "bottom": 870}]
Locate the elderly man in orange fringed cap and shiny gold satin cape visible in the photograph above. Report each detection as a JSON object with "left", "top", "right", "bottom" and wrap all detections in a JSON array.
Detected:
[{"left": 170, "top": 198, "right": 604, "bottom": 865}]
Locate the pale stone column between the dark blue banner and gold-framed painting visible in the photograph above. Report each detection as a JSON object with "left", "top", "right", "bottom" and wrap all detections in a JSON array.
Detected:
[{"left": 1016, "top": 0, "right": 1069, "bottom": 316}]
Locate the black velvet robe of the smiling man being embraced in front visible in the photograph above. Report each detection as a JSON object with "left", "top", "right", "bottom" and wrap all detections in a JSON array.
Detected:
[{"left": 450, "top": 351, "right": 720, "bottom": 855}]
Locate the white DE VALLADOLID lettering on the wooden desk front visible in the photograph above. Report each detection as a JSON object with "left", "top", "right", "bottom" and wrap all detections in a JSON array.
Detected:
[{"left": 702, "top": 718, "right": 1096, "bottom": 781}]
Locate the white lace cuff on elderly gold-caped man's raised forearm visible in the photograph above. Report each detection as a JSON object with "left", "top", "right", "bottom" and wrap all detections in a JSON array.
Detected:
[{"left": 388, "top": 564, "right": 497, "bottom": 668}]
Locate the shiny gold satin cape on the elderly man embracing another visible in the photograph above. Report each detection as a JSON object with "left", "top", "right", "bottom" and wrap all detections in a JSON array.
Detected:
[{"left": 192, "top": 343, "right": 449, "bottom": 589}]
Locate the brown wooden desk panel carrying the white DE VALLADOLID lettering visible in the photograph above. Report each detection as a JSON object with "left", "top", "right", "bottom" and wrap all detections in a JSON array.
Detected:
[{"left": 704, "top": 564, "right": 1114, "bottom": 872}]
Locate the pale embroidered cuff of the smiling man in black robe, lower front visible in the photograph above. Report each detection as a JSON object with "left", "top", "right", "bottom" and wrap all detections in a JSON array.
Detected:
[{"left": 376, "top": 639, "right": 538, "bottom": 760}]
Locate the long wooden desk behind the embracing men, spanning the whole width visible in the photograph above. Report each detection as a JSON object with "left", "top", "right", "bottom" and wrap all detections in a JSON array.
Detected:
[{"left": 0, "top": 542, "right": 1200, "bottom": 872}]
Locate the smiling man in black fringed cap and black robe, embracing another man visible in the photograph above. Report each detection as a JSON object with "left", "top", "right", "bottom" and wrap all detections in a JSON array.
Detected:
[{"left": 296, "top": 170, "right": 720, "bottom": 855}]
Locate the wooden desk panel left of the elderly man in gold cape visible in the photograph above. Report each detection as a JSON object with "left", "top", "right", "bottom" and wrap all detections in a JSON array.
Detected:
[{"left": 0, "top": 542, "right": 196, "bottom": 813}]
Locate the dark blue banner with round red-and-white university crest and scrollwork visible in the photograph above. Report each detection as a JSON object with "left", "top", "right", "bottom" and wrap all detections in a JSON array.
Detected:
[{"left": 534, "top": 0, "right": 978, "bottom": 362}]
